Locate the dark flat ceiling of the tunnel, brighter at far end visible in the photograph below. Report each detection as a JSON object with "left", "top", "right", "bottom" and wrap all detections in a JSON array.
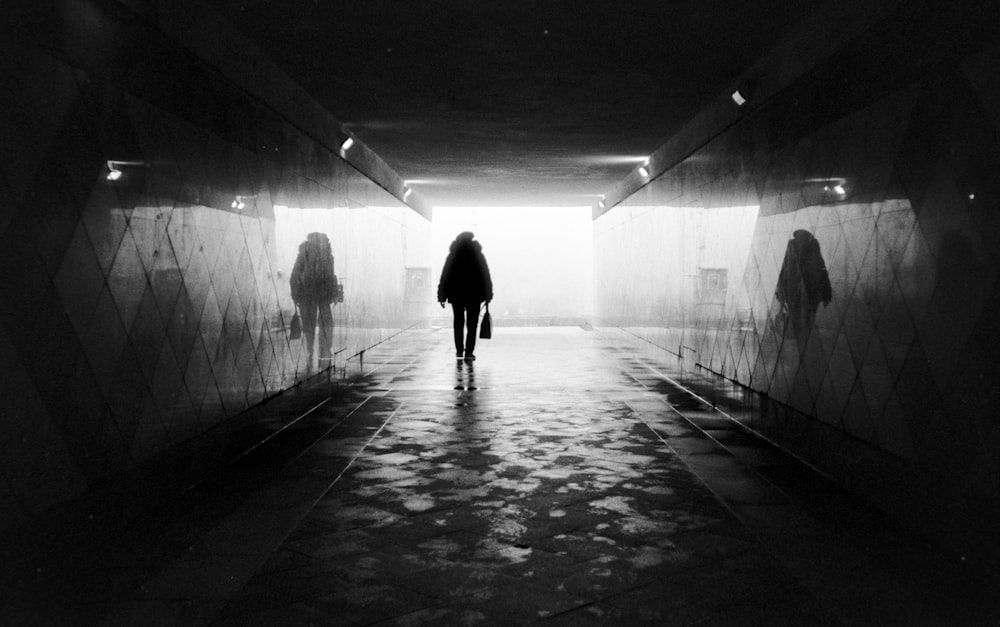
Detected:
[{"left": 208, "top": 0, "right": 820, "bottom": 206}]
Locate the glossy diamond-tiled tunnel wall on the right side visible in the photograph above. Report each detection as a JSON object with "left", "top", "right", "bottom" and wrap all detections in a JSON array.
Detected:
[{"left": 595, "top": 3, "right": 1000, "bottom": 559}]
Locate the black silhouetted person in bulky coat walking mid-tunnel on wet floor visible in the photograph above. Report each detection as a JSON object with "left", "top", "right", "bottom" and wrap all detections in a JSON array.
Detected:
[{"left": 438, "top": 231, "right": 493, "bottom": 362}]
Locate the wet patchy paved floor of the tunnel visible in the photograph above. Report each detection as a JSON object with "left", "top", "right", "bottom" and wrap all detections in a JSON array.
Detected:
[{"left": 2, "top": 327, "right": 1000, "bottom": 626}]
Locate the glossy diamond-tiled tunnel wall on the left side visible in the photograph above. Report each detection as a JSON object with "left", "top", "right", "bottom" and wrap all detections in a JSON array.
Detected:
[{"left": 0, "top": 2, "right": 430, "bottom": 530}]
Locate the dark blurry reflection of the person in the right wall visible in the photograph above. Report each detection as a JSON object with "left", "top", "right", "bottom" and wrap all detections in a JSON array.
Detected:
[{"left": 774, "top": 229, "right": 833, "bottom": 342}]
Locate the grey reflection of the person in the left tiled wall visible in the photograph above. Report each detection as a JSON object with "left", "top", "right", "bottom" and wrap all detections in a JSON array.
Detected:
[{"left": 291, "top": 233, "right": 340, "bottom": 368}]
